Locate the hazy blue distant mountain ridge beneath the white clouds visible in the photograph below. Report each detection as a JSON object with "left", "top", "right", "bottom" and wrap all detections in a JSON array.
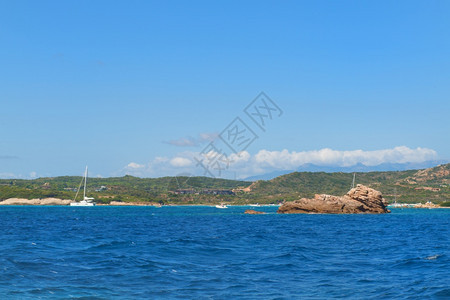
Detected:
[{"left": 244, "top": 160, "right": 448, "bottom": 181}]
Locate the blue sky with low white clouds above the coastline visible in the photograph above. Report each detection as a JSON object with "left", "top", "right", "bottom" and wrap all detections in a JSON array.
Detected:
[{"left": 0, "top": 1, "right": 450, "bottom": 178}]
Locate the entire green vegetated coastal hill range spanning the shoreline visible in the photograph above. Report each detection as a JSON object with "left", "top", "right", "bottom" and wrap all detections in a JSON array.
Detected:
[{"left": 0, "top": 164, "right": 450, "bottom": 204}]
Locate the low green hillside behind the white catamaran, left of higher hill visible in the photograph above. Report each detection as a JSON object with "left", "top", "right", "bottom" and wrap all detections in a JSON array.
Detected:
[{"left": 0, "top": 175, "right": 251, "bottom": 204}]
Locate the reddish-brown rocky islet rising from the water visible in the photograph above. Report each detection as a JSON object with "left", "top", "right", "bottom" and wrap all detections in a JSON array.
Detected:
[{"left": 278, "top": 184, "right": 390, "bottom": 214}]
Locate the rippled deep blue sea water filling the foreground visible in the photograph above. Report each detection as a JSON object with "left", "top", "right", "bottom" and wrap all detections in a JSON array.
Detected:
[{"left": 0, "top": 206, "right": 450, "bottom": 299}]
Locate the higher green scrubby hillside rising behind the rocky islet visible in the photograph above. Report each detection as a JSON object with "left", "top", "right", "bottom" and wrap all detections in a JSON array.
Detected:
[{"left": 251, "top": 164, "right": 450, "bottom": 203}]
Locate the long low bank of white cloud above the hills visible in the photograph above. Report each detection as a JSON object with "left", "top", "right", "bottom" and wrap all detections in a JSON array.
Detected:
[{"left": 117, "top": 146, "right": 438, "bottom": 178}]
